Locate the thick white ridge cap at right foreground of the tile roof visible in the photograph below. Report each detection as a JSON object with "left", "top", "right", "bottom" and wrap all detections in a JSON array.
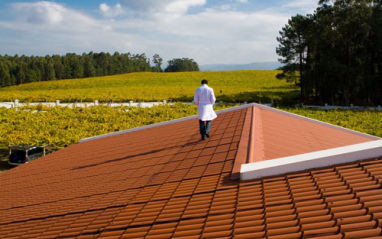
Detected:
[{"left": 240, "top": 140, "right": 382, "bottom": 180}]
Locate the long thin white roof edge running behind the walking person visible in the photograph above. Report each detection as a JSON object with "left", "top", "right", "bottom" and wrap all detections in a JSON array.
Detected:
[{"left": 79, "top": 103, "right": 255, "bottom": 143}]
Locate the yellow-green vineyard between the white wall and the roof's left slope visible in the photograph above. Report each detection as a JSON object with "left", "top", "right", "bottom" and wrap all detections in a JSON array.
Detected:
[{"left": 0, "top": 103, "right": 233, "bottom": 149}]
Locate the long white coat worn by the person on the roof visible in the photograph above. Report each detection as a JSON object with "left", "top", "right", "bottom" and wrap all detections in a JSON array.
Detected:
[{"left": 194, "top": 84, "right": 217, "bottom": 121}]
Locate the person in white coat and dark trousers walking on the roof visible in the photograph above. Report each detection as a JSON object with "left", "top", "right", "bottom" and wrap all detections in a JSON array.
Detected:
[{"left": 194, "top": 79, "right": 217, "bottom": 140}]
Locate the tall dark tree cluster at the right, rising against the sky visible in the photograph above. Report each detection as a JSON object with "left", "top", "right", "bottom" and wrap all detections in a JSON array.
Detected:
[{"left": 276, "top": 0, "right": 382, "bottom": 105}]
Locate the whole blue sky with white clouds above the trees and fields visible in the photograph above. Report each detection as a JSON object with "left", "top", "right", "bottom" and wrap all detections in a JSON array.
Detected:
[{"left": 0, "top": 0, "right": 318, "bottom": 65}]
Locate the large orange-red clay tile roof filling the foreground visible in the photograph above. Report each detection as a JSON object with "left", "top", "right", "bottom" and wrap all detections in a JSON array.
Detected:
[{"left": 0, "top": 104, "right": 382, "bottom": 239}]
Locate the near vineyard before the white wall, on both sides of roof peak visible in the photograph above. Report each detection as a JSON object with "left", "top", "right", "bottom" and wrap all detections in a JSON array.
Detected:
[{"left": 0, "top": 103, "right": 382, "bottom": 149}]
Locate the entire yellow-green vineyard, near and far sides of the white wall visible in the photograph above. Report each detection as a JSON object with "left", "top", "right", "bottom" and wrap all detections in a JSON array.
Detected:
[{"left": 0, "top": 71, "right": 382, "bottom": 171}]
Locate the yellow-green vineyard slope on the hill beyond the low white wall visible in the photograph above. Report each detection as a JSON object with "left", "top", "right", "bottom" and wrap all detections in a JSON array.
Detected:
[{"left": 0, "top": 70, "right": 299, "bottom": 104}]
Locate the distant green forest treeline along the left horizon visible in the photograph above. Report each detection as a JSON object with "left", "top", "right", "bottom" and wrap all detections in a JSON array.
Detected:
[{"left": 0, "top": 52, "right": 199, "bottom": 87}]
